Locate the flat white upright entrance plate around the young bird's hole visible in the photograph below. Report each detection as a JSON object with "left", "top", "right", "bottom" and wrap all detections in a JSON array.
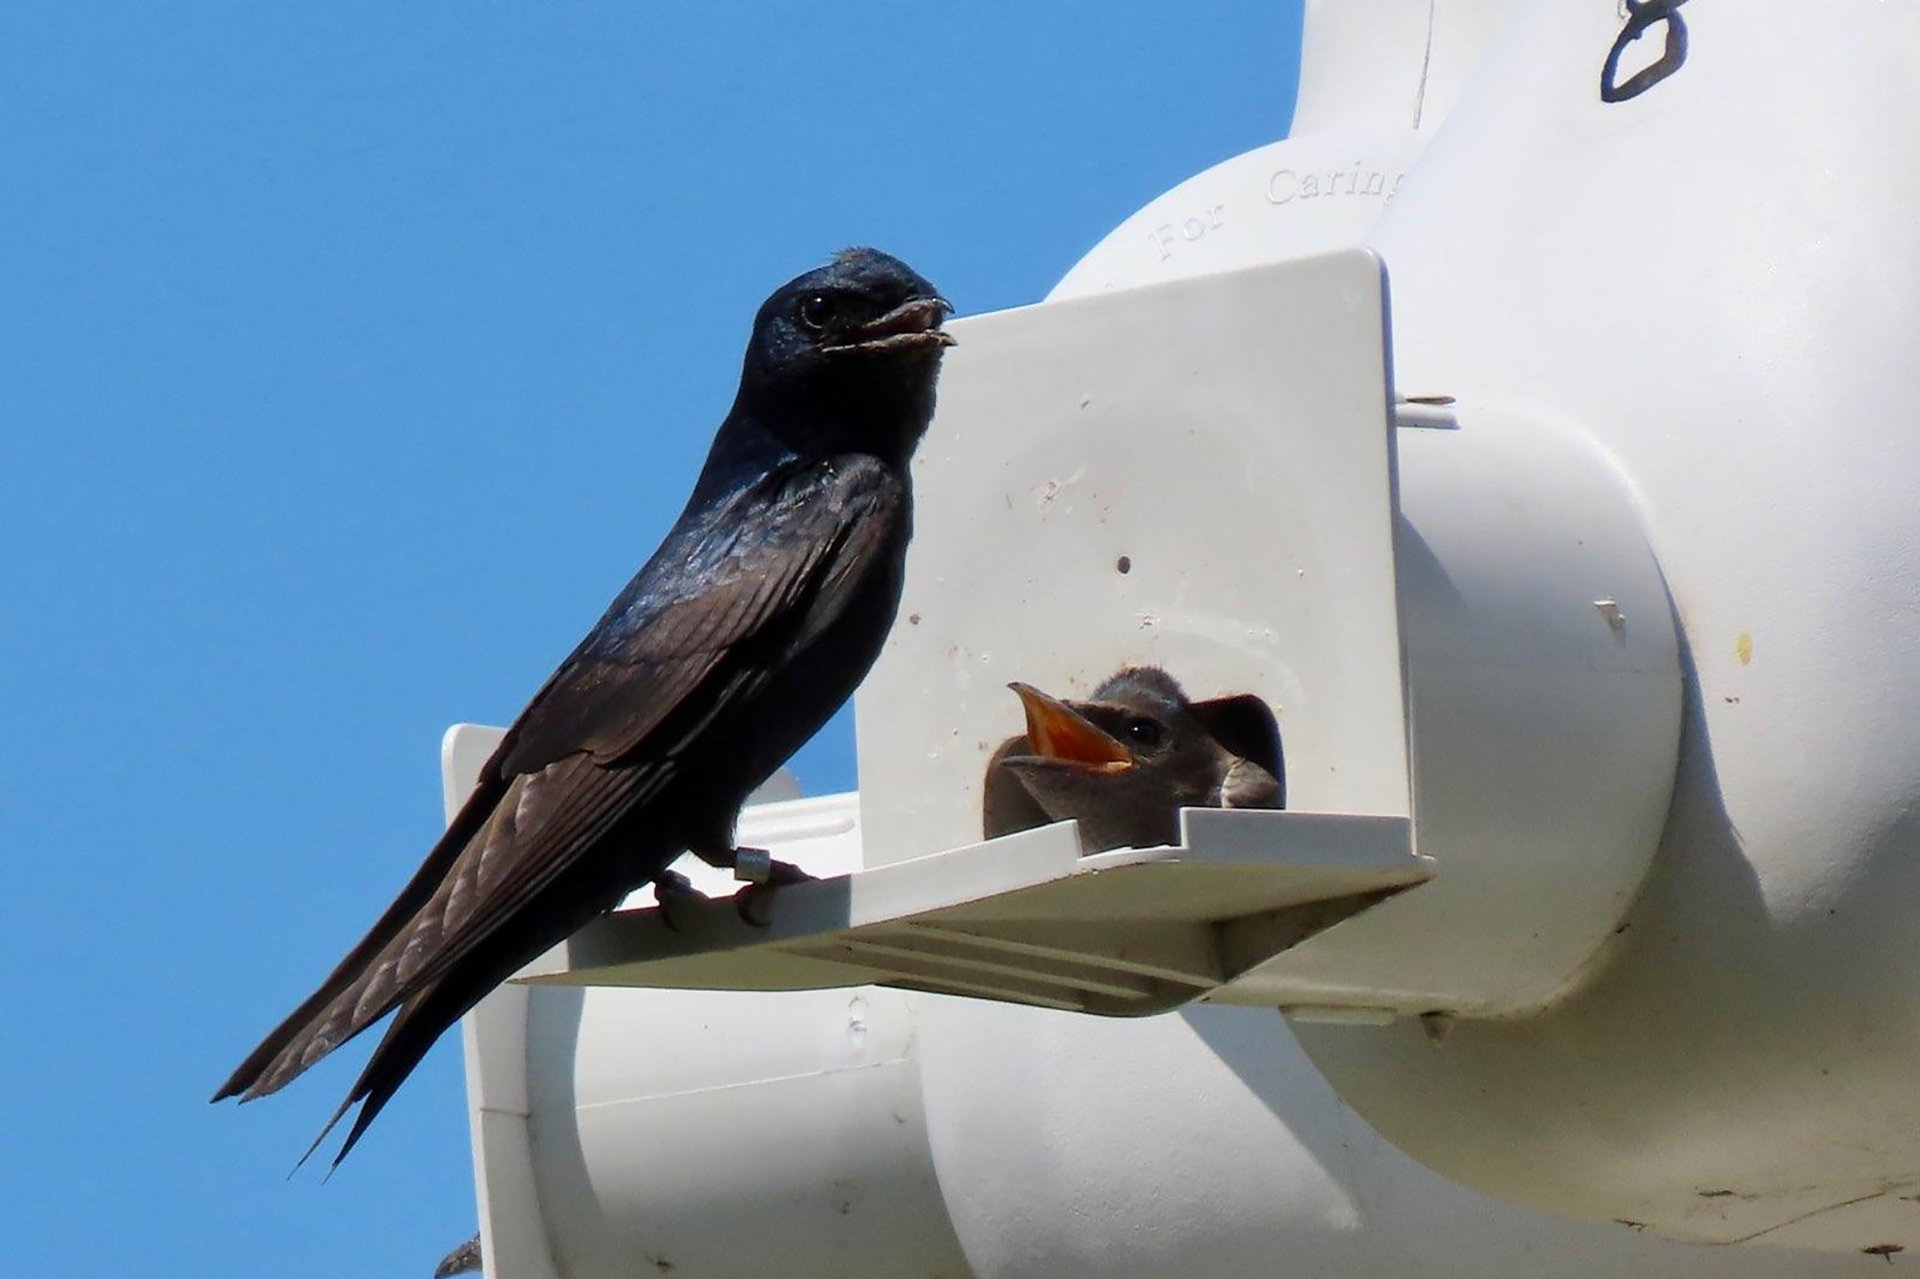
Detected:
[{"left": 854, "top": 252, "right": 1417, "bottom": 862}]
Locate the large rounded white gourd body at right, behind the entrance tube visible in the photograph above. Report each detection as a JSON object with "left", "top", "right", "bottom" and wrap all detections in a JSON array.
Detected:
[{"left": 1300, "top": 0, "right": 1920, "bottom": 1236}]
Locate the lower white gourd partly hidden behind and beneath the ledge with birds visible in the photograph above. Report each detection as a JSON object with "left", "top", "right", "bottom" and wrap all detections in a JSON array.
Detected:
[{"left": 449, "top": 798, "right": 1851, "bottom": 1279}]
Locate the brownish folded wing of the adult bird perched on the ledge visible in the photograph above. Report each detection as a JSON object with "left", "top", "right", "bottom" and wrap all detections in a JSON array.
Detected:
[{"left": 225, "top": 457, "right": 906, "bottom": 1097}]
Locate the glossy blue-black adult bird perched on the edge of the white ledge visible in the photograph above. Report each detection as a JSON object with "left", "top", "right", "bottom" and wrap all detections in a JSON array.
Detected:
[{"left": 213, "top": 248, "right": 952, "bottom": 1166}]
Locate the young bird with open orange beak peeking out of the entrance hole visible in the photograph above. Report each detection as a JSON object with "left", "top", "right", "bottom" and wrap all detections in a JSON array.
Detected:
[{"left": 985, "top": 666, "right": 1286, "bottom": 853}]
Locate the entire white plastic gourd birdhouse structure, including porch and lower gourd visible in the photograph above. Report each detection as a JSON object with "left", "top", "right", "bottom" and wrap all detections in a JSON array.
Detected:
[{"left": 447, "top": 0, "right": 1920, "bottom": 1279}]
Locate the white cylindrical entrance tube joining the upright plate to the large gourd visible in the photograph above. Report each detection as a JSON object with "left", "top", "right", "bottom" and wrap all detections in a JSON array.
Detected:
[{"left": 1242, "top": 407, "right": 1682, "bottom": 1016}]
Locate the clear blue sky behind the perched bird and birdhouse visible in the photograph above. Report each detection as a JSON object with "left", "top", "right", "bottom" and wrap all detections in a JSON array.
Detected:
[{"left": 0, "top": 0, "right": 1300, "bottom": 1279}]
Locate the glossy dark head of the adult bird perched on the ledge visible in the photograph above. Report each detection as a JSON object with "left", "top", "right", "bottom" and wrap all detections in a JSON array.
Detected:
[{"left": 739, "top": 248, "right": 952, "bottom": 465}]
